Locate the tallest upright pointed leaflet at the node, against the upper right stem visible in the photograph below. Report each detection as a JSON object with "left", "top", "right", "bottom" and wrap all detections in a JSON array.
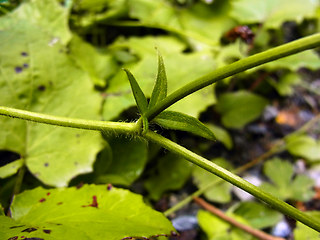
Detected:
[{"left": 149, "top": 53, "right": 167, "bottom": 109}]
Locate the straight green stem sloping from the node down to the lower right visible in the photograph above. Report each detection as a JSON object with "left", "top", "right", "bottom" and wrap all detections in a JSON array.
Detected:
[{"left": 144, "top": 131, "right": 320, "bottom": 232}]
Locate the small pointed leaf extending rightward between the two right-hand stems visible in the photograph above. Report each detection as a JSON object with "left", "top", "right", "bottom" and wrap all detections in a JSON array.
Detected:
[{"left": 153, "top": 111, "right": 216, "bottom": 140}]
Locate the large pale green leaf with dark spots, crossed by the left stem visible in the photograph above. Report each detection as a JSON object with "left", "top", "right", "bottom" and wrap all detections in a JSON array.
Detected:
[{"left": 0, "top": 5, "right": 104, "bottom": 187}]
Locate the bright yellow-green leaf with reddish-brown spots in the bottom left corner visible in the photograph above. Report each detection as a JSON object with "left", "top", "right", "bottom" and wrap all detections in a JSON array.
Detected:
[{"left": 0, "top": 185, "right": 174, "bottom": 240}]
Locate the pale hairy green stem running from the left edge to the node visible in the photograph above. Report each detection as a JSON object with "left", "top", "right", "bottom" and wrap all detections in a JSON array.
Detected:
[{"left": 0, "top": 106, "right": 140, "bottom": 134}]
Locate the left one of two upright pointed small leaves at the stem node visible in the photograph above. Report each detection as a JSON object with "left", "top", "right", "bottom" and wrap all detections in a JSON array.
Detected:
[{"left": 123, "top": 69, "right": 148, "bottom": 115}]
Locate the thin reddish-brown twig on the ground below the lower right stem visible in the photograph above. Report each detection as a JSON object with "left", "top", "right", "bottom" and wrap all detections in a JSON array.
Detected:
[{"left": 193, "top": 197, "right": 285, "bottom": 240}]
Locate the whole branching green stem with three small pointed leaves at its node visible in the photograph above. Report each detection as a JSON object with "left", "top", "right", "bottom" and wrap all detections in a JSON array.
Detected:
[{"left": 0, "top": 31, "right": 320, "bottom": 238}]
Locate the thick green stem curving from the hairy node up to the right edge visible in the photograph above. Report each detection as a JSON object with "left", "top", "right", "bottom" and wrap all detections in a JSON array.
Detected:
[{"left": 145, "top": 33, "right": 320, "bottom": 120}]
